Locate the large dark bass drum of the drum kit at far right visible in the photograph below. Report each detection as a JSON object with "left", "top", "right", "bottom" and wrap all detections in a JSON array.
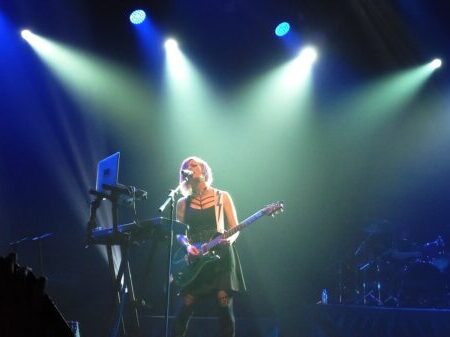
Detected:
[{"left": 398, "top": 260, "right": 449, "bottom": 308}]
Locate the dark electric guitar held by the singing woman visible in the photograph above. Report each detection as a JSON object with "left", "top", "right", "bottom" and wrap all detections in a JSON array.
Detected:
[{"left": 172, "top": 201, "right": 284, "bottom": 288}]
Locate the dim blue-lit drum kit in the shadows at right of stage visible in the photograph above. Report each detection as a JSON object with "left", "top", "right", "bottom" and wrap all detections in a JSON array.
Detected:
[{"left": 337, "top": 221, "right": 450, "bottom": 308}]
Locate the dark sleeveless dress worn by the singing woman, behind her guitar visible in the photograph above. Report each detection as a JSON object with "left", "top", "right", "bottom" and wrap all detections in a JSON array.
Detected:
[{"left": 182, "top": 197, "right": 246, "bottom": 296}]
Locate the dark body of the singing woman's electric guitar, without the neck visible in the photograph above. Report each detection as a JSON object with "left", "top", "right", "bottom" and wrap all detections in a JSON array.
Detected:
[{"left": 172, "top": 244, "right": 220, "bottom": 288}]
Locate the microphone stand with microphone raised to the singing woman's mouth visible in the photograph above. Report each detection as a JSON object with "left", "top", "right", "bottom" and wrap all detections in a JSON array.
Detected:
[{"left": 159, "top": 181, "right": 187, "bottom": 337}]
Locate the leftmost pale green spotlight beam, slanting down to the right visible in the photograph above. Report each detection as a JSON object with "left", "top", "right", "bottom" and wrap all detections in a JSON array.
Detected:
[{"left": 23, "top": 33, "right": 154, "bottom": 128}]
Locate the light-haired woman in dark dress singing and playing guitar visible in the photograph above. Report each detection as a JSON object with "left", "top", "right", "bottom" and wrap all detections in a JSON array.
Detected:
[{"left": 172, "top": 157, "right": 245, "bottom": 337}]
